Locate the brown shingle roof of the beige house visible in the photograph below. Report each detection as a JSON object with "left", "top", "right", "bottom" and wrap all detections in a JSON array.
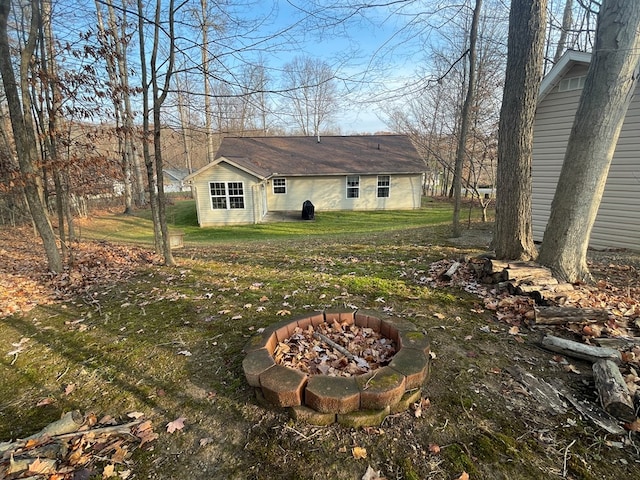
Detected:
[{"left": 189, "top": 135, "right": 424, "bottom": 178}]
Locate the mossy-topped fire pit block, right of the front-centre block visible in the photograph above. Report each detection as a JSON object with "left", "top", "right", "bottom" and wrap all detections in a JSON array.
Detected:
[{"left": 356, "top": 367, "right": 405, "bottom": 410}]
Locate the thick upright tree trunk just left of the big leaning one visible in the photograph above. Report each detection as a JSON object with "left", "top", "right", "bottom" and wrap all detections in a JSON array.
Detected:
[{"left": 493, "top": 0, "right": 547, "bottom": 260}]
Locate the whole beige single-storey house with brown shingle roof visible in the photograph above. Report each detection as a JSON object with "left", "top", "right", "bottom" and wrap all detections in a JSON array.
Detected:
[{"left": 185, "top": 135, "right": 424, "bottom": 227}]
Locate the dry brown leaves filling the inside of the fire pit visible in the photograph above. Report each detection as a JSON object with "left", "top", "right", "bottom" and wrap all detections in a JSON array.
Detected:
[{"left": 274, "top": 322, "right": 396, "bottom": 377}]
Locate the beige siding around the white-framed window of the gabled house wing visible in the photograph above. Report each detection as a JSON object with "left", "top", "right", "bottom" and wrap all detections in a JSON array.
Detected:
[{"left": 193, "top": 163, "right": 264, "bottom": 227}]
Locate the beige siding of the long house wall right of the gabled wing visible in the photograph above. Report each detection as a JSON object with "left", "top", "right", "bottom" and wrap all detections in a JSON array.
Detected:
[{"left": 267, "top": 175, "right": 421, "bottom": 211}]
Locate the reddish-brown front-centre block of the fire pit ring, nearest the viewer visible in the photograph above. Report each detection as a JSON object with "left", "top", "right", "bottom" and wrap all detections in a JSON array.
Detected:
[{"left": 304, "top": 375, "right": 360, "bottom": 413}]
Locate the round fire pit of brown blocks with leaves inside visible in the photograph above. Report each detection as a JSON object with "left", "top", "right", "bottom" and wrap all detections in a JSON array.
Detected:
[{"left": 242, "top": 310, "right": 430, "bottom": 426}]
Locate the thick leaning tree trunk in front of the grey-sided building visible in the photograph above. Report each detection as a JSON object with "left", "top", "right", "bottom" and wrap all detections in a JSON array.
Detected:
[{"left": 539, "top": 0, "right": 640, "bottom": 282}]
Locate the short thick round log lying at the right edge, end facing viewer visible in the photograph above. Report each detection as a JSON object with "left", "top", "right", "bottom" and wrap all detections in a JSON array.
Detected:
[{"left": 593, "top": 360, "right": 636, "bottom": 422}]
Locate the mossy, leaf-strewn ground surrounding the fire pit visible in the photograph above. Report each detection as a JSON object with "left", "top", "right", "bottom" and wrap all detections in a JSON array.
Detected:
[{"left": 0, "top": 205, "right": 640, "bottom": 480}]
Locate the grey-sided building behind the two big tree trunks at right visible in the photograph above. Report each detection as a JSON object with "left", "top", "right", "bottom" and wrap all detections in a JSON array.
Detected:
[{"left": 532, "top": 51, "right": 640, "bottom": 250}]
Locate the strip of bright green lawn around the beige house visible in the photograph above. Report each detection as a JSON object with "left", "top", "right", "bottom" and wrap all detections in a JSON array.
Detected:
[{"left": 81, "top": 200, "right": 480, "bottom": 244}]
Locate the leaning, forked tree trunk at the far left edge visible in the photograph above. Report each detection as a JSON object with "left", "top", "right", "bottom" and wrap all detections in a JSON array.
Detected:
[{"left": 0, "top": 0, "right": 62, "bottom": 273}]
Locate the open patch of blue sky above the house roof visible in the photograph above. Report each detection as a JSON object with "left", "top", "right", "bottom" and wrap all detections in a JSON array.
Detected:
[{"left": 241, "top": 0, "right": 436, "bottom": 134}]
